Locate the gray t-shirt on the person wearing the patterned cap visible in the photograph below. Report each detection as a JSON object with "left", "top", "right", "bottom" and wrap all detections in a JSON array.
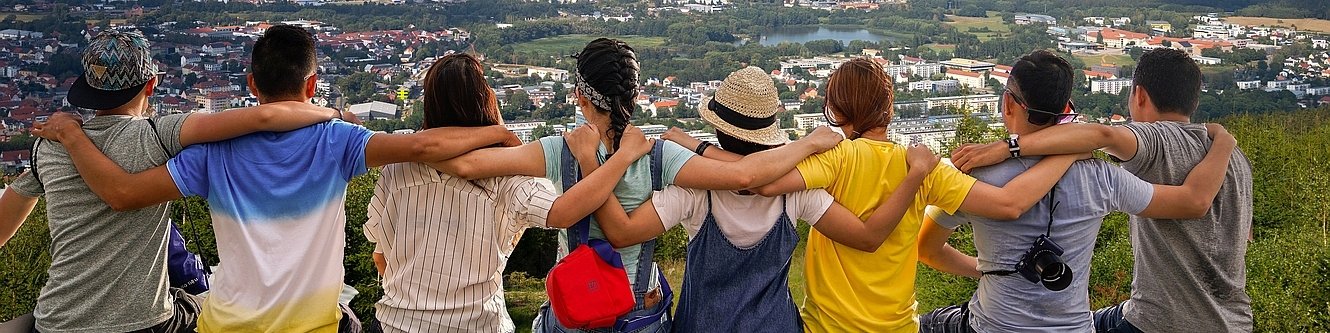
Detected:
[{"left": 12, "top": 115, "right": 188, "bottom": 332}]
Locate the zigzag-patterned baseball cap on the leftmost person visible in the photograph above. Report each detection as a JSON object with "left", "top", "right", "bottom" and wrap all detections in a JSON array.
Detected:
[{"left": 68, "top": 31, "right": 157, "bottom": 109}]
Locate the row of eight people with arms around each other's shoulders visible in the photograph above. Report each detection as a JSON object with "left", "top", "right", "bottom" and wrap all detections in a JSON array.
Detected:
[{"left": 0, "top": 21, "right": 1252, "bottom": 332}]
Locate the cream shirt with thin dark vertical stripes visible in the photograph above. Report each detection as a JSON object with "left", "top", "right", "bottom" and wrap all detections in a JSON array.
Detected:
[{"left": 364, "top": 163, "right": 557, "bottom": 332}]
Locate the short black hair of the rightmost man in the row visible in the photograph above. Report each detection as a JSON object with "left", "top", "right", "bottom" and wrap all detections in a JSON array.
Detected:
[{"left": 1132, "top": 48, "right": 1201, "bottom": 116}]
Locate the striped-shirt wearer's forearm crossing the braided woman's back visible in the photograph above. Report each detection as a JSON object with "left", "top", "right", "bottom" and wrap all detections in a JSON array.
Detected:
[{"left": 547, "top": 155, "right": 633, "bottom": 228}]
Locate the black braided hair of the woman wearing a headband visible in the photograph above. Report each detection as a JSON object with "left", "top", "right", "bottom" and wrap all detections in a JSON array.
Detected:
[{"left": 577, "top": 39, "right": 640, "bottom": 151}]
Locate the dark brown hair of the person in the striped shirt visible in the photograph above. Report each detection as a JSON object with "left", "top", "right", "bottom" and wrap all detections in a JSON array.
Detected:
[{"left": 424, "top": 53, "right": 500, "bottom": 128}]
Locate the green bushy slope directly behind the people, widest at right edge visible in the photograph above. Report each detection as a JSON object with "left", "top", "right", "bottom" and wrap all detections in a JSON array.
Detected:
[{"left": 0, "top": 108, "right": 1330, "bottom": 332}]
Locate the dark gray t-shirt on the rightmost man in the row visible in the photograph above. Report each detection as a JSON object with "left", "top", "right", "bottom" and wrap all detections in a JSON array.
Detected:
[{"left": 1123, "top": 121, "right": 1252, "bottom": 332}]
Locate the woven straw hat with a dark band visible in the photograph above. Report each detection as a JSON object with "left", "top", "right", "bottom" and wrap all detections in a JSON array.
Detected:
[{"left": 698, "top": 67, "right": 790, "bottom": 145}]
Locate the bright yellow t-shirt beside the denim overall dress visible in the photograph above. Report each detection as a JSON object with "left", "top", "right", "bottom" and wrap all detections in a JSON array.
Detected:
[{"left": 798, "top": 139, "right": 975, "bottom": 332}]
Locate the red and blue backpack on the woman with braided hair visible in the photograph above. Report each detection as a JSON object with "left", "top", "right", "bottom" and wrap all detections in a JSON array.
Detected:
[{"left": 545, "top": 140, "right": 672, "bottom": 330}]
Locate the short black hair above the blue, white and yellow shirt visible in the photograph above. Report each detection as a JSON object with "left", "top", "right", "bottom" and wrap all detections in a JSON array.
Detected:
[{"left": 250, "top": 24, "right": 317, "bottom": 97}]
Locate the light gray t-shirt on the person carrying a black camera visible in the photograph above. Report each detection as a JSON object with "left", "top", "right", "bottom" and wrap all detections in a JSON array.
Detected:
[{"left": 930, "top": 157, "right": 1154, "bottom": 332}]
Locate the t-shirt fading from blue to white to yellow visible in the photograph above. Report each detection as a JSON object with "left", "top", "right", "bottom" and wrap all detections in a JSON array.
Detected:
[{"left": 166, "top": 120, "right": 374, "bottom": 332}]
